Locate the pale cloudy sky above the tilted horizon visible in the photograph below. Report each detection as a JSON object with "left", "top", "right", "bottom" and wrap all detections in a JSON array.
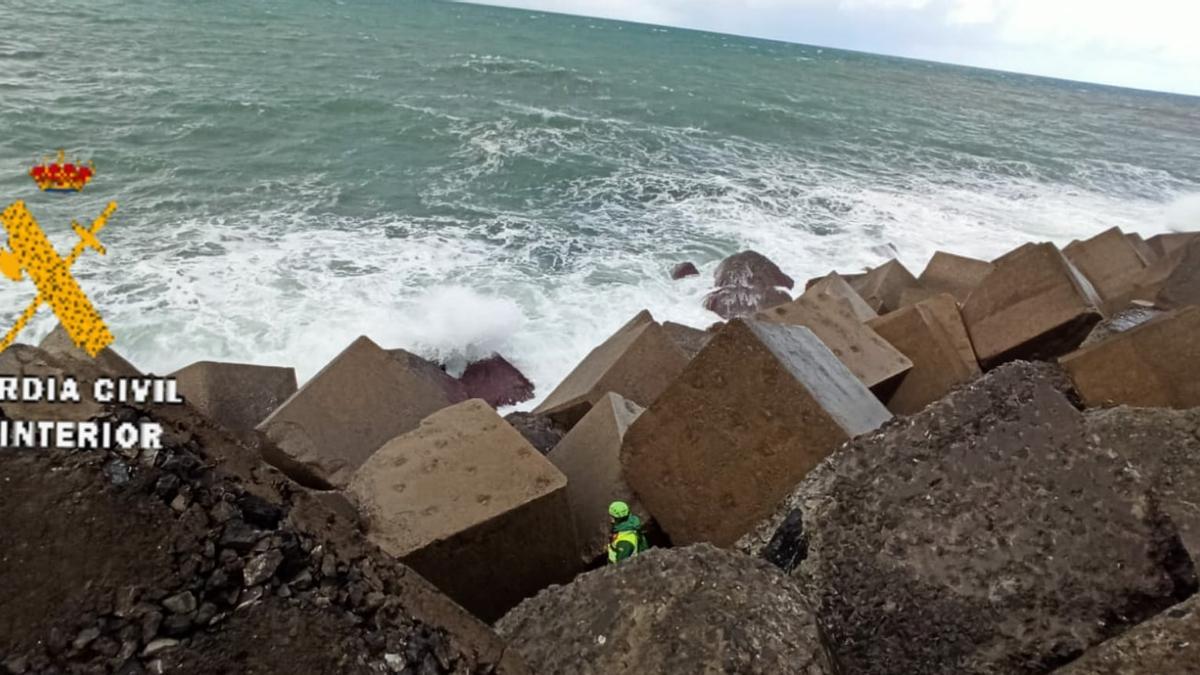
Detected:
[{"left": 463, "top": 0, "right": 1200, "bottom": 95}]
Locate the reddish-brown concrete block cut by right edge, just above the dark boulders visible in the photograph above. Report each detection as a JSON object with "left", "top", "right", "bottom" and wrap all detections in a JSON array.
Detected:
[{"left": 1061, "top": 307, "right": 1200, "bottom": 408}]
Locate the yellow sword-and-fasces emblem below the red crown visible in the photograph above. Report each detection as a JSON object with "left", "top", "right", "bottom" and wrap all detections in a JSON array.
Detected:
[{"left": 0, "top": 202, "right": 116, "bottom": 357}]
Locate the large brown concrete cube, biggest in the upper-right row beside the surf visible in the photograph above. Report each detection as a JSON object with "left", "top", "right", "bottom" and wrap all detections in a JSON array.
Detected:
[{"left": 962, "top": 244, "right": 1102, "bottom": 370}]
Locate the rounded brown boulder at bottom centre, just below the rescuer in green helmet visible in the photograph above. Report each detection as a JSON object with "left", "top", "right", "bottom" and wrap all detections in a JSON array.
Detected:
[{"left": 496, "top": 544, "right": 836, "bottom": 675}]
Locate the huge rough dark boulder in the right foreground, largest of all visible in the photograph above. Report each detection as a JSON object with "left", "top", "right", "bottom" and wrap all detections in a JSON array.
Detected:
[{"left": 757, "top": 363, "right": 1195, "bottom": 675}]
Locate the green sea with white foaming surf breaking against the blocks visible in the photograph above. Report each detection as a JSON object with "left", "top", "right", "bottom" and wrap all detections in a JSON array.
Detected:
[{"left": 0, "top": 0, "right": 1200, "bottom": 407}]
